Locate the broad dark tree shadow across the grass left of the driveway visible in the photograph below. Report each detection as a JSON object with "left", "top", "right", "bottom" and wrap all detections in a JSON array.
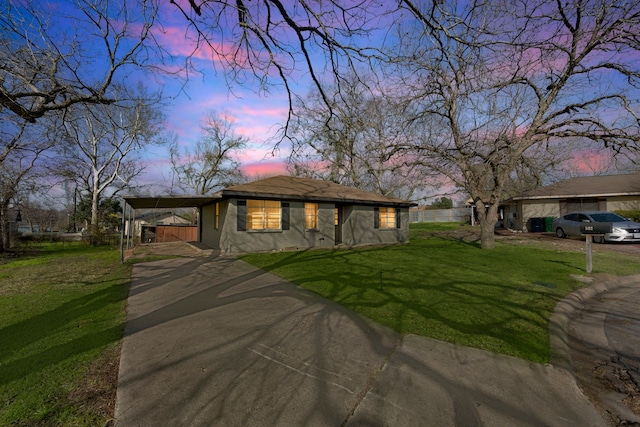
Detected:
[{"left": 0, "top": 284, "right": 126, "bottom": 384}]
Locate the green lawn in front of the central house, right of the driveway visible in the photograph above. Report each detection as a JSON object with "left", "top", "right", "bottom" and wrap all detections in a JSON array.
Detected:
[{"left": 242, "top": 224, "right": 640, "bottom": 363}]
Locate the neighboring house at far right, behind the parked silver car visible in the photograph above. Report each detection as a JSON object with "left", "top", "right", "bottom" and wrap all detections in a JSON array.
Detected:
[{"left": 504, "top": 173, "right": 640, "bottom": 231}]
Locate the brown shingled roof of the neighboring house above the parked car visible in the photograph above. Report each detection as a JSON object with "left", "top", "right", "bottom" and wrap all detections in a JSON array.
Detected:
[{"left": 512, "top": 173, "right": 640, "bottom": 200}]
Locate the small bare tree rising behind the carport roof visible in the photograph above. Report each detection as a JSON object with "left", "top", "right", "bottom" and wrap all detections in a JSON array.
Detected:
[{"left": 170, "top": 111, "right": 248, "bottom": 195}]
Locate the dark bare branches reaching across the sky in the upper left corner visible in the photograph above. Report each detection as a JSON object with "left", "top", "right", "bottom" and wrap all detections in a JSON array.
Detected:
[{"left": 0, "top": 0, "right": 170, "bottom": 122}]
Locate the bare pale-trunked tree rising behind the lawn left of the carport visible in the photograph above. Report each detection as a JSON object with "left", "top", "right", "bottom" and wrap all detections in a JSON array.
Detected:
[{"left": 56, "top": 90, "right": 164, "bottom": 239}]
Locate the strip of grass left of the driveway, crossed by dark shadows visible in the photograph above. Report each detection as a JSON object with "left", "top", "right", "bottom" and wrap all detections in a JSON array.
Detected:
[{"left": 0, "top": 243, "right": 130, "bottom": 426}]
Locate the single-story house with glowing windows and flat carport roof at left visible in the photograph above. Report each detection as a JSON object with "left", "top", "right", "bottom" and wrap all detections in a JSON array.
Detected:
[{"left": 124, "top": 176, "right": 415, "bottom": 253}]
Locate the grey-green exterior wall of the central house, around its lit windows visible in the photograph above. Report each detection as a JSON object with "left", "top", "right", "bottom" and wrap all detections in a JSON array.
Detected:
[{"left": 202, "top": 199, "right": 409, "bottom": 253}]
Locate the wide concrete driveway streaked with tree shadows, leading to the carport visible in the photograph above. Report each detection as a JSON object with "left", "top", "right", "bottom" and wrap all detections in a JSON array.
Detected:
[{"left": 116, "top": 252, "right": 605, "bottom": 426}]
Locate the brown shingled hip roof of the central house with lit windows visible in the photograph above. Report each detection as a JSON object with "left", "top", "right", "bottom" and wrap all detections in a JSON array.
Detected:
[{"left": 219, "top": 175, "right": 415, "bottom": 207}]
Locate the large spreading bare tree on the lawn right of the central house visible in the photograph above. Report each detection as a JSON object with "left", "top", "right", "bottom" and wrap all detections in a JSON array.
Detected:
[{"left": 395, "top": 0, "right": 640, "bottom": 248}]
